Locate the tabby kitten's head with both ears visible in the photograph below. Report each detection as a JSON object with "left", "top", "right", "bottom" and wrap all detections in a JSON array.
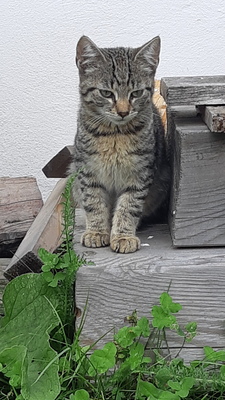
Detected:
[{"left": 76, "top": 36, "right": 160, "bottom": 125}]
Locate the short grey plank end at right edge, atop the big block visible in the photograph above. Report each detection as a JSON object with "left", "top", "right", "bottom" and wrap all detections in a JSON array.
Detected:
[{"left": 198, "top": 105, "right": 225, "bottom": 132}]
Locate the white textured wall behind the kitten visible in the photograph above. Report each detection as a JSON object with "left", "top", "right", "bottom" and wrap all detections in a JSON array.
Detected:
[{"left": 0, "top": 0, "right": 225, "bottom": 198}]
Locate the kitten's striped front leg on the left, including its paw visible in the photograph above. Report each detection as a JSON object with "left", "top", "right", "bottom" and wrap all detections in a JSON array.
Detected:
[{"left": 81, "top": 187, "right": 111, "bottom": 247}]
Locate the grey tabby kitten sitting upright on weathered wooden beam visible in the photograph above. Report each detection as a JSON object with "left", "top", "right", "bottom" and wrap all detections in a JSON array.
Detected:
[{"left": 71, "top": 36, "right": 170, "bottom": 253}]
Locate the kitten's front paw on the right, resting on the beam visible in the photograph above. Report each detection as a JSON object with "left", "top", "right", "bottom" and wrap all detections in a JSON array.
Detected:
[{"left": 110, "top": 235, "right": 141, "bottom": 253}]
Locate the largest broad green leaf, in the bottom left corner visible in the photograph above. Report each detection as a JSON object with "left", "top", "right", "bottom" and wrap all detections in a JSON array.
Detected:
[{"left": 0, "top": 274, "right": 60, "bottom": 400}]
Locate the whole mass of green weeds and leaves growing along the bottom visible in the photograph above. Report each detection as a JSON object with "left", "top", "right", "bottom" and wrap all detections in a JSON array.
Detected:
[{"left": 0, "top": 177, "right": 225, "bottom": 400}]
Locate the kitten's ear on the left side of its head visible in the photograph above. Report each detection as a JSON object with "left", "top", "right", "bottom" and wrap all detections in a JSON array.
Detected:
[{"left": 76, "top": 36, "right": 105, "bottom": 73}]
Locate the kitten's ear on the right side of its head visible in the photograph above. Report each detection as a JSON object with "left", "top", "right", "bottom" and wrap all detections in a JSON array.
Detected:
[{"left": 134, "top": 36, "right": 161, "bottom": 72}]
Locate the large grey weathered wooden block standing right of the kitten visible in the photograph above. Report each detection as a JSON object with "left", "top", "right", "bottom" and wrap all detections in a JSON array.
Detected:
[{"left": 168, "top": 107, "right": 225, "bottom": 247}]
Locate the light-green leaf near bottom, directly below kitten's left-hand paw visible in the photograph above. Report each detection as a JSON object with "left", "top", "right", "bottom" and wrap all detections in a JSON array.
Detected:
[{"left": 88, "top": 342, "right": 117, "bottom": 376}]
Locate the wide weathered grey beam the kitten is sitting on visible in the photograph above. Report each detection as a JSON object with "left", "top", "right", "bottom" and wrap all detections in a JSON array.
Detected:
[{"left": 75, "top": 212, "right": 225, "bottom": 359}]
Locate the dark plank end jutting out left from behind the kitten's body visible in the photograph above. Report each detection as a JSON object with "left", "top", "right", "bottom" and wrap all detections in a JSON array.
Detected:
[{"left": 42, "top": 146, "right": 73, "bottom": 178}]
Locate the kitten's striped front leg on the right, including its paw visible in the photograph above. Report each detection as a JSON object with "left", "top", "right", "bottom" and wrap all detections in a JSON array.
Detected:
[{"left": 110, "top": 191, "right": 144, "bottom": 253}]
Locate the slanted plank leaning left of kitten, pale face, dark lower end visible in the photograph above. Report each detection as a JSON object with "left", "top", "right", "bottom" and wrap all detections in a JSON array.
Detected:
[{"left": 5, "top": 178, "right": 67, "bottom": 279}]
